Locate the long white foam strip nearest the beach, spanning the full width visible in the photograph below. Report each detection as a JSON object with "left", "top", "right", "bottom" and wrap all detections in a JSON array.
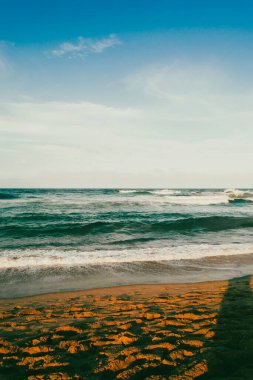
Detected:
[{"left": 0, "top": 243, "right": 253, "bottom": 270}]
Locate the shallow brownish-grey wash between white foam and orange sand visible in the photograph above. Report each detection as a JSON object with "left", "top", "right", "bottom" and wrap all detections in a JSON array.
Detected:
[{"left": 0, "top": 253, "right": 253, "bottom": 300}]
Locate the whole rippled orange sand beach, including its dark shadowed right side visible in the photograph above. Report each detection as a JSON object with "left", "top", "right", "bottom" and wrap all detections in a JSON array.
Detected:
[{"left": 0, "top": 276, "right": 253, "bottom": 380}]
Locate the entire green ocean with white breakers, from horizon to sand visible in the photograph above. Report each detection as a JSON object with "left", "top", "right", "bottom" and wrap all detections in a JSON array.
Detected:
[{"left": 0, "top": 189, "right": 253, "bottom": 297}]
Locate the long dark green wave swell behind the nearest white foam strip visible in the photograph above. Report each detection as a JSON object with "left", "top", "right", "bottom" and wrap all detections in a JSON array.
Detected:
[{"left": 0, "top": 215, "right": 253, "bottom": 239}]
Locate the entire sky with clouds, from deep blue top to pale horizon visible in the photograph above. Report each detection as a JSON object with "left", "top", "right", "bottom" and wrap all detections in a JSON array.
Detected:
[{"left": 0, "top": 0, "right": 253, "bottom": 188}]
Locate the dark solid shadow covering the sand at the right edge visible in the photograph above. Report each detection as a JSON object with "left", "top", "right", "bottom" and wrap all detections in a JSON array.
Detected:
[{"left": 200, "top": 276, "right": 253, "bottom": 380}]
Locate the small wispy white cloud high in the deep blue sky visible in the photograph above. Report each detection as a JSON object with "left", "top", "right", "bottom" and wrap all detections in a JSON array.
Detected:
[{"left": 50, "top": 34, "right": 122, "bottom": 58}]
